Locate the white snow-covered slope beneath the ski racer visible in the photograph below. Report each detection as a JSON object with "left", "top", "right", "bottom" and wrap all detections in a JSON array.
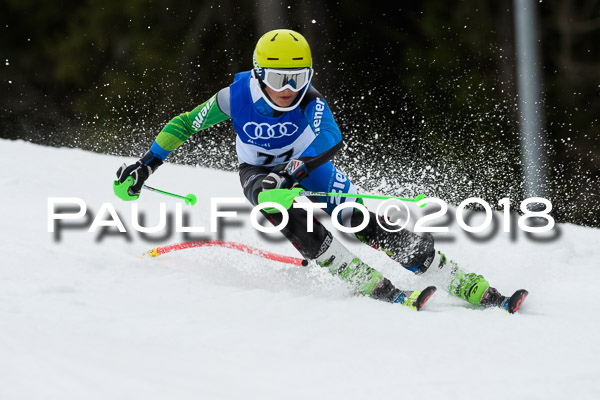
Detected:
[{"left": 0, "top": 140, "right": 600, "bottom": 400}]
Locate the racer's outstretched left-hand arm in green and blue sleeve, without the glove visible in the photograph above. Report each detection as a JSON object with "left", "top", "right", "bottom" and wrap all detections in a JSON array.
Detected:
[{"left": 150, "top": 87, "right": 229, "bottom": 160}]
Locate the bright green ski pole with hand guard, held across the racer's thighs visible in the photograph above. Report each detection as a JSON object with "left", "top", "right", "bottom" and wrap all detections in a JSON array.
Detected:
[{"left": 258, "top": 188, "right": 426, "bottom": 214}]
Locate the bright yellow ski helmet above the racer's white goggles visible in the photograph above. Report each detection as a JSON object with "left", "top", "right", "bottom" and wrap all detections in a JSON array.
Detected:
[{"left": 253, "top": 29, "right": 312, "bottom": 72}]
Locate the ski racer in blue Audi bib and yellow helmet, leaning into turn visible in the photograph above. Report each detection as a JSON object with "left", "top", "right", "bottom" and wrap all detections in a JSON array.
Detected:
[{"left": 117, "top": 29, "right": 527, "bottom": 313}]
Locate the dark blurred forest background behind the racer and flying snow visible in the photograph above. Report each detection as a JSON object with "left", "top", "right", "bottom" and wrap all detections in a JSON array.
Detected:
[{"left": 0, "top": 0, "right": 600, "bottom": 226}]
